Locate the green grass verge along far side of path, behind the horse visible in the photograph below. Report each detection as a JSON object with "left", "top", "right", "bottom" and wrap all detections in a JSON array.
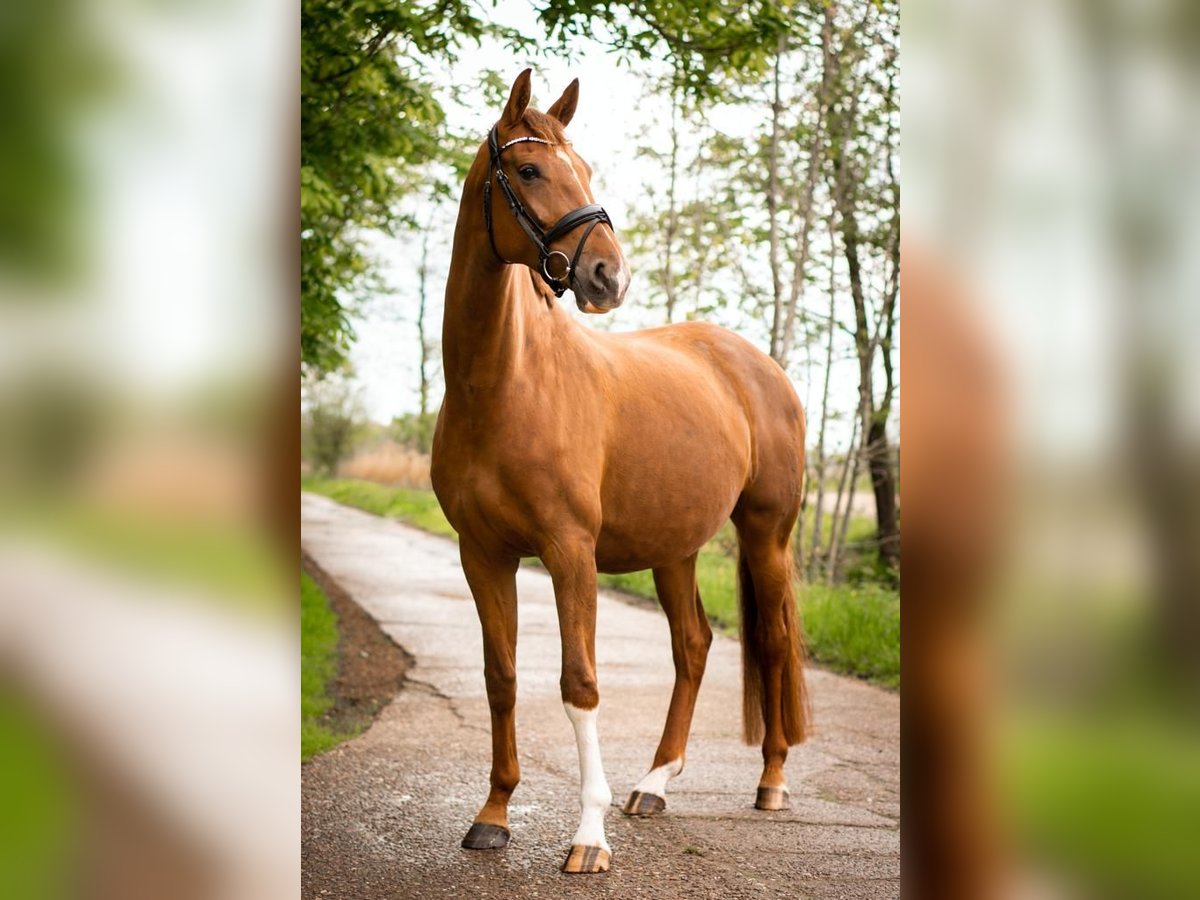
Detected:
[{"left": 301, "top": 478, "right": 900, "bottom": 688}]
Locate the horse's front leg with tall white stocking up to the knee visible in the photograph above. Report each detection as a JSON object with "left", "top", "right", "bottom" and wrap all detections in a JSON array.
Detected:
[{"left": 542, "top": 540, "right": 612, "bottom": 872}]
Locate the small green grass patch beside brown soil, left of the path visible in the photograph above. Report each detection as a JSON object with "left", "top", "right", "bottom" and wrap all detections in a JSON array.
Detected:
[{"left": 300, "top": 572, "right": 354, "bottom": 762}]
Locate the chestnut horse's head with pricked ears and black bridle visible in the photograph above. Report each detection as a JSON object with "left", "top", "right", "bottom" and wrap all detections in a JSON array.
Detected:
[{"left": 475, "top": 68, "right": 629, "bottom": 313}]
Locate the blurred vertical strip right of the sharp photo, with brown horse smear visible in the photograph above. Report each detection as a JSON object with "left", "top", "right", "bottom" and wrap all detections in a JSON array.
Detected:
[{"left": 901, "top": 0, "right": 1200, "bottom": 898}]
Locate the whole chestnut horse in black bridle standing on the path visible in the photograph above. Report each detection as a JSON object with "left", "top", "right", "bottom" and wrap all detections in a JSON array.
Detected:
[{"left": 432, "top": 70, "right": 806, "bottom": 872}]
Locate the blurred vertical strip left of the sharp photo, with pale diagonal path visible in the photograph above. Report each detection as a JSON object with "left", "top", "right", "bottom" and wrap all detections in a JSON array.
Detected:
[{"left": 0, "top": 0, "right": 300, "bottom": 898}]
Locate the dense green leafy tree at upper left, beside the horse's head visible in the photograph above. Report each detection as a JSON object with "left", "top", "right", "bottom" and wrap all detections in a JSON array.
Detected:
[{"left": 300, "top": 0, "right": 508, "bottom": 372}]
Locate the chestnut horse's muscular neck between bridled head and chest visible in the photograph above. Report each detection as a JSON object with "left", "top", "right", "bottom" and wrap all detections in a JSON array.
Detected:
[{"left": 442, "top": 204, "right": 570, "bottom": 398}]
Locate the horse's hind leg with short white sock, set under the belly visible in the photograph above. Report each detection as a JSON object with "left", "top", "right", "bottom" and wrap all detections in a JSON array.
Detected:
[{"left": 625, "top": 554, "right": 713, "bottom": 816}]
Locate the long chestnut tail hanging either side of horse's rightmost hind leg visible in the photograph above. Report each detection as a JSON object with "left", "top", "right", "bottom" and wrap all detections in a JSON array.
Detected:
[{"left": 738, "top": 547, "right": 810, "bottom": 745}]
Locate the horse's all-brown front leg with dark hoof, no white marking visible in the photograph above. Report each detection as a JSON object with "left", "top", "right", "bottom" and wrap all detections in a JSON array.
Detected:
[{"left": 460, "top": 541, "right": 521, "bottom": 850}]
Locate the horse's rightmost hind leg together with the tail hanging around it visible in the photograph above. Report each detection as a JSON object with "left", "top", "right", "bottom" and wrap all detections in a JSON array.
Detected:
[{"left": 733, "top": 503, "right": 808, "bottom": 810}]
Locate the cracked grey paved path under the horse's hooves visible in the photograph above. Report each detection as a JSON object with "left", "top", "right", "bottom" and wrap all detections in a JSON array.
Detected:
[{"left": 301, "top": 494, "right": 900, "bottom": 899}]
